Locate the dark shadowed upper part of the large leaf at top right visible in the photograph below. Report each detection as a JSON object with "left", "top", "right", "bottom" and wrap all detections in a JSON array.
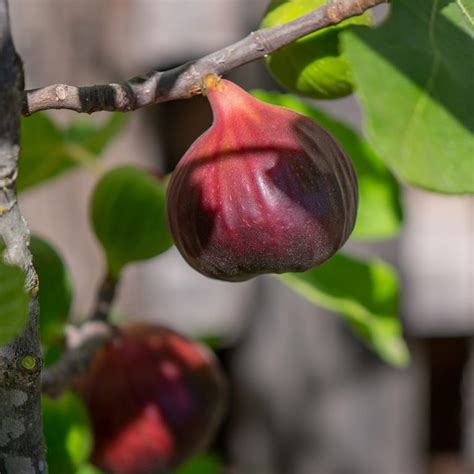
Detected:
[{"left": 353, "top": 0, "right": 474, "bottom": 131}]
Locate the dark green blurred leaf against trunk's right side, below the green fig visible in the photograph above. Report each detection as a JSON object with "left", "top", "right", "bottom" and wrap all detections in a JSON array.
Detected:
[{"left": 30, "top": 236, "right": 72, "bottom": 345}]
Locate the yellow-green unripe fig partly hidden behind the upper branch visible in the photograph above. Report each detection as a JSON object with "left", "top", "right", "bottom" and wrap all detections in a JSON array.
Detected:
[{"left": 261, "top": 0, "right": 372, "bottom": 99}]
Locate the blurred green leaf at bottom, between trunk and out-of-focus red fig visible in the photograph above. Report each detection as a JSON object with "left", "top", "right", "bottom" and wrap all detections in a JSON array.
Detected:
[{"left": 42, "top": 392, "right": 92, "bottom": 474}]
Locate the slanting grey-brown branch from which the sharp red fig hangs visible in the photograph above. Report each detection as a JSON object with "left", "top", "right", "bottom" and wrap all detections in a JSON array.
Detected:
[{"left": 23, "top": 0, "right": 388, "bottom": 115}]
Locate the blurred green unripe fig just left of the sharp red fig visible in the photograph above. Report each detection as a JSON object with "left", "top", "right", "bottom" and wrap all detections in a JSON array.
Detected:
[{"left": 90, "top": 166, "right": 172, "bottom": 278}]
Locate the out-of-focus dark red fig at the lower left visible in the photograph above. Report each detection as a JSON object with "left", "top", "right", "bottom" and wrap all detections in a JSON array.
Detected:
[{"left": 77, "top": 324, "right": 226, "bottom": 474}]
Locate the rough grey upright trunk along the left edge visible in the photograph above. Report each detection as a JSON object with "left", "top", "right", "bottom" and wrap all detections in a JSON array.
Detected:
[{"left": 0, "top": 0, "right": 46, "bottom": 473}]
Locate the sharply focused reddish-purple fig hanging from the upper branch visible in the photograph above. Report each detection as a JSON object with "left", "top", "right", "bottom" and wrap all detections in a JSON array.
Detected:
[{"left": 167, "top": 76, "right": 357, "bottom": 281}]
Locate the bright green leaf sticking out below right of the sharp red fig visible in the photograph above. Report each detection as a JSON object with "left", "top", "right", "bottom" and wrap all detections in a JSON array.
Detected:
[{"left": 277, "top": 253, "right": 410, "bottom": 367}]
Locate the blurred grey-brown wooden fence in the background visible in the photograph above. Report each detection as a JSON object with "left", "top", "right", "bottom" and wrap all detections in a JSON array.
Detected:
[{"left": 11, "top": 0, "right": 474, "bottom": 474}]
